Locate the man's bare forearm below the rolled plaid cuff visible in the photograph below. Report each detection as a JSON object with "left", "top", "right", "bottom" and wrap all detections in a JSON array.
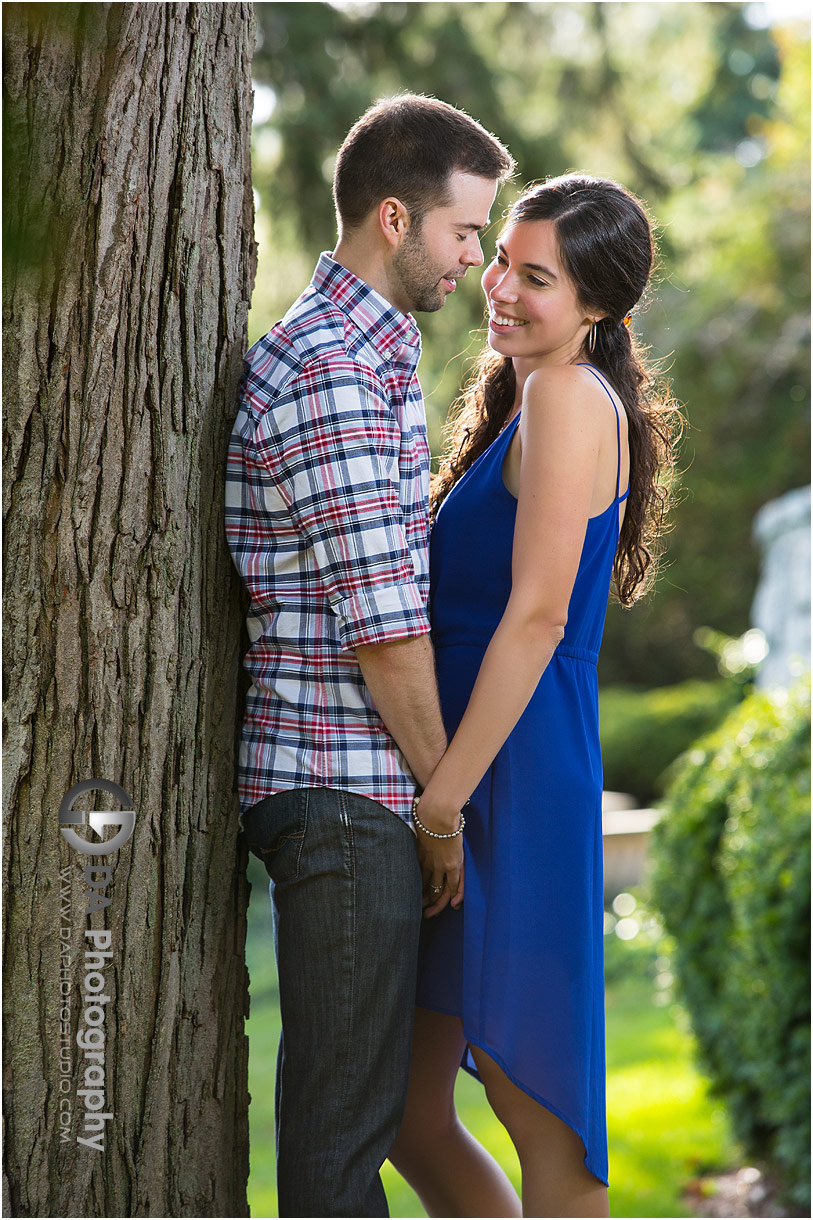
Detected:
[{"left": 355, "top": 634, "right": 447, "bottom": 788}]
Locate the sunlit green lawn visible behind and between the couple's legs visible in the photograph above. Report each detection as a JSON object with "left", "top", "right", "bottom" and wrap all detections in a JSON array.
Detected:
[{"left": 247, "top": 861, "right": 736, "bottom": 1218}]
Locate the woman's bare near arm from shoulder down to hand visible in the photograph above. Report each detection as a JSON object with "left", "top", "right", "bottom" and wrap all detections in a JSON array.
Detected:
[{"left": 419, "top": 366, "right": 602, "bottom": 915}]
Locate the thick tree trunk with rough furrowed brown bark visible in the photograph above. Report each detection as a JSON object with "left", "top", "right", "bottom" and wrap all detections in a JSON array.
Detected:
[{"left": 2, "top": 4, "right": 255, "bottom": 1216}]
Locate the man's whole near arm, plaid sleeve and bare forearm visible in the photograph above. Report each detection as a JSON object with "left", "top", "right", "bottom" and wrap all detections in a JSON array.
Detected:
[{"left": 258, "top": 354, "right": 446, "bottom": 786}]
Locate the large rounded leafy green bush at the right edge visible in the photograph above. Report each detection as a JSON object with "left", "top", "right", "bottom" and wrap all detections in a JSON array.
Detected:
[{"left": 652, "top": 688, "right": 811, "bottom": 1214}]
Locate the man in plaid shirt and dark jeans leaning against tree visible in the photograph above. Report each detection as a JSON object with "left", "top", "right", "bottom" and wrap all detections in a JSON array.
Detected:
[{"left": 226, "top": 94, "right": 513, "bottom": 1216}]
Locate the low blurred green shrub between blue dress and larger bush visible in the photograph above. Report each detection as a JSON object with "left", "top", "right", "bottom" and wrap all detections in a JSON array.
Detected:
[{"left": 598, "top": 680, "right": 740, "bottom": 805}]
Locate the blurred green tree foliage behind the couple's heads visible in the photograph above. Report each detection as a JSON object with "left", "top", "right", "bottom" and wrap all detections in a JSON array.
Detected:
[{"left": 250, "top": 2, "right": 811, "bottom": 687}]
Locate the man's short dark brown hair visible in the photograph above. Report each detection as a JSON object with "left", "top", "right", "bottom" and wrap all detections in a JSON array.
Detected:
[{"left": 333, "top": 93, "right": 514, "bottom": 229}]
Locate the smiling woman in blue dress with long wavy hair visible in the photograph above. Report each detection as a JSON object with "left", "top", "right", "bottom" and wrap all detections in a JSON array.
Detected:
[{"left": 391, "top": 176, "right": 675, "bottom": 1216}]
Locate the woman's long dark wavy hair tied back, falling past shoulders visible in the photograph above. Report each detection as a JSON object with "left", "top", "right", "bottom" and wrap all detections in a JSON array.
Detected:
[{"left": 431, "top": 174, "right": 681, "bottom": 606}]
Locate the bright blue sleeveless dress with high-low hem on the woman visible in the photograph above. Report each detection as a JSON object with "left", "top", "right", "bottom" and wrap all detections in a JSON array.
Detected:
[{"left": 417, "top": 365, "right": 629, "bottom": 1183}]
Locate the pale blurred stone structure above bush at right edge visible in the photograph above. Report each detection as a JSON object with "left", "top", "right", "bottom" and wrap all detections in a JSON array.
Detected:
[{"left": 751, "top": 487, "right": 811, "bottom": 689}]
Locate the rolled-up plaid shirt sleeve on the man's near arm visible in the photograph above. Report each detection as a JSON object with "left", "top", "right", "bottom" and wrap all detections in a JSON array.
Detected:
[{"left": 256, "top": 356, "right": 430, "bottom": 650}]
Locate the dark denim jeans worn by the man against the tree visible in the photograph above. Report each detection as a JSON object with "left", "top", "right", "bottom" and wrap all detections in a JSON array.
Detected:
[{"left": 243, "top": 788, "right": 421, "bottom": 1216}]
